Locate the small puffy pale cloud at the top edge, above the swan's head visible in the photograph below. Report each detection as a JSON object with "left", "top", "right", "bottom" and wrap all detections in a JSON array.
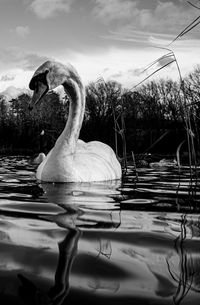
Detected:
[{"left": 30, "top": 0, "right": 73, "bottom": 19}]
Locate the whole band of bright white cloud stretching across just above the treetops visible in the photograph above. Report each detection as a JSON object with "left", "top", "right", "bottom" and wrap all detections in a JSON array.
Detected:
[{"left": 0, "top": 40, "right": 200, "bottom": 91}]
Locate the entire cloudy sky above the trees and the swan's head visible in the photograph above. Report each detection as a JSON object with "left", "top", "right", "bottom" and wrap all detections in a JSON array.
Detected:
[{"left": 0, "top": 0, "right": 200, "bottom": 92}]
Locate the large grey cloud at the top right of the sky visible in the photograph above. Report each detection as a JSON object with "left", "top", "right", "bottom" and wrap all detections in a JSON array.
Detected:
[{"left": 93, "top": 0, "right": 198, "bottom": 35}]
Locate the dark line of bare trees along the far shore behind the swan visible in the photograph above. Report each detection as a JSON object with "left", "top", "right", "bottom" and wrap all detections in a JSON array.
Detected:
[{"left": 0, "top": 67, "right": 200, "bottom": 155}]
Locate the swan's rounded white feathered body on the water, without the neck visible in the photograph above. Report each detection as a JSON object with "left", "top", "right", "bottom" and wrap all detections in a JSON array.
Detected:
[{"left": 36, "top": 140, "right": 121, "bottom": 182}]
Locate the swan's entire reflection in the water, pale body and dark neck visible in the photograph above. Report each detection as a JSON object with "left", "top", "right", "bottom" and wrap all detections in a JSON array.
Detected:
[{"left": 18, "top": 181, "right": 119, "bottom": 305}]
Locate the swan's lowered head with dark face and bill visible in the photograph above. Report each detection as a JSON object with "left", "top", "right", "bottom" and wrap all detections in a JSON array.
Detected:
[{"left": 29, "top": 60, "right": 81, "bottom": 110}]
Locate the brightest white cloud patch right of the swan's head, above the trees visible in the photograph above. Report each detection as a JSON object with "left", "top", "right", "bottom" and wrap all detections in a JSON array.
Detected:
[{"left": 56, "top": 47, "right": 178, "bottom": 88}]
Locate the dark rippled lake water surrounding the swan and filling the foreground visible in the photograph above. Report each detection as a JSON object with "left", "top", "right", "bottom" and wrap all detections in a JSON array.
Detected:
[{"left": 0, "top": 157, "right": 200, "bottom": 305}]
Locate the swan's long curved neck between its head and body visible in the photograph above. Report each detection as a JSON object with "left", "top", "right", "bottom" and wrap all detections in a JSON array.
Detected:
[{"left": 56, "top": 80, "right": 85, "bottom": 153}]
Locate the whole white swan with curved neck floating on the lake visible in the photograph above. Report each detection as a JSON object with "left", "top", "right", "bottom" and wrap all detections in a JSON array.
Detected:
[{"left": 29, "top": 61, "right": 122, "bottom": 182}]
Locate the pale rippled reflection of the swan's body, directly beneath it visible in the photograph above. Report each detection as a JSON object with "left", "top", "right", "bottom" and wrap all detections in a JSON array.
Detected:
[{"left": 41, "top": 181, "right": 120, "bottom": 228}]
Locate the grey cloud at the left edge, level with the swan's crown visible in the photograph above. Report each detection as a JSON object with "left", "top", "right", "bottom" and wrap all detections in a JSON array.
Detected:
[{"left": 0, "top": 48, "right": 50, "bottom": 70}]
